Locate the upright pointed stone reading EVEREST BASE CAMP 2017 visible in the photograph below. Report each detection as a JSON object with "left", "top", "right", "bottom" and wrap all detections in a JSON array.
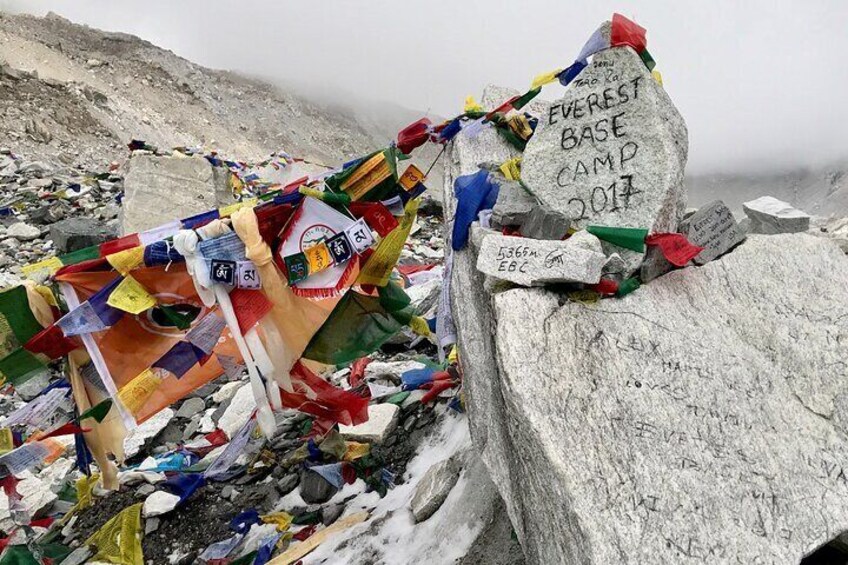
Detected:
[{"left": 521, "top": 27, "right": 688, "bottom": 270}]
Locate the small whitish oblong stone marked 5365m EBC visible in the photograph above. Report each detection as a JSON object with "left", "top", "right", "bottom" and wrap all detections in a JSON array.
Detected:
[{"left": 477, "top": 234, "right": 607, "bottom": 286}]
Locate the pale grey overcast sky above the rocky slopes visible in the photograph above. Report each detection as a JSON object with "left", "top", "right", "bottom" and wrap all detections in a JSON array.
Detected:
[{"left": 0, "top": 0, "right": 848, "bottom": 172}]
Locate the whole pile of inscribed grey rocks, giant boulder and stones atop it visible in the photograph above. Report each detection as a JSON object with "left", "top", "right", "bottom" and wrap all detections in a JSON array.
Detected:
[{"left": 440, "top": 37, "right": 848, "bottom": 565}]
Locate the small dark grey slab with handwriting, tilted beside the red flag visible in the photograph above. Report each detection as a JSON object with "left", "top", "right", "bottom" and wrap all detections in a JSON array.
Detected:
[{"left": 680, "top": 200, "right": 747, "bottom": 265}]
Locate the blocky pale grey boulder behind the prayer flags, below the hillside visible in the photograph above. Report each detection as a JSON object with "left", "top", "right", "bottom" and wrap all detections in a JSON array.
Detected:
[{"left": 121, "top": 153, "right": 233, "bottom": 234}]
